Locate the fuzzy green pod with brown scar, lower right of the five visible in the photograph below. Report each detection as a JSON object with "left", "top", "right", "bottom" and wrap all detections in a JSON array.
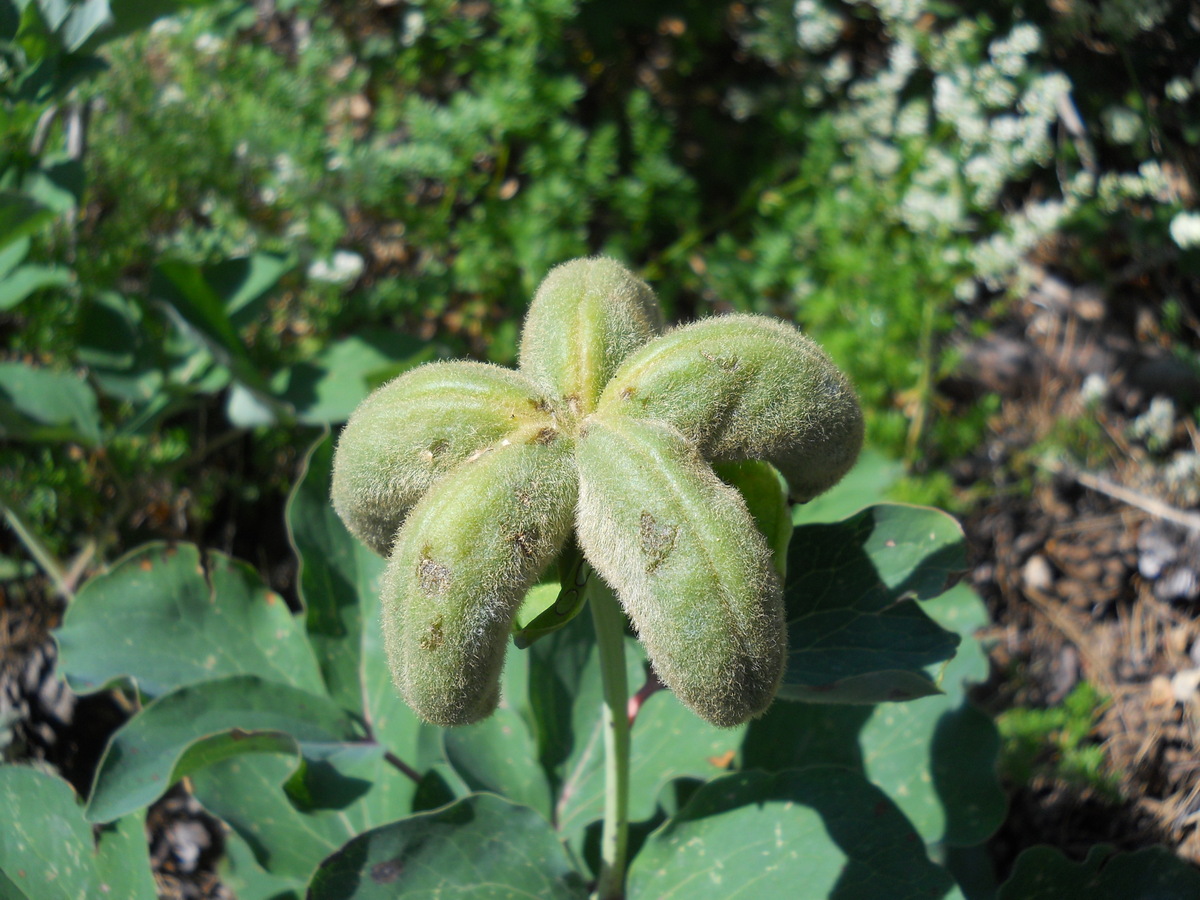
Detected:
[{"left": 576, "top": 415, "right": 787, "bottom": 726}]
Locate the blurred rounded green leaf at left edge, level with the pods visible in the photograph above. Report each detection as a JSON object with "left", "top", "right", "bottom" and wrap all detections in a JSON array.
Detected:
[{"left": 0, "top": 362, "right": 101, "bottom": 445}]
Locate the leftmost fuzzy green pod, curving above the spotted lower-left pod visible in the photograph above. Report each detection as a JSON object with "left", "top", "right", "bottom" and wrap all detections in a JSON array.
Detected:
[{"left": 332, "top": 362, "right": 553, "bottom": 556}]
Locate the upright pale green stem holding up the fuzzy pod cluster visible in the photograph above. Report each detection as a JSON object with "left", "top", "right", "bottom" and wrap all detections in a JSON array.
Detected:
[{"left": 588, "top": 574, "right": 629, "bottom": 900}]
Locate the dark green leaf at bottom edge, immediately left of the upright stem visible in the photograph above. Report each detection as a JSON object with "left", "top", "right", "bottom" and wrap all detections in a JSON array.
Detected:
[{"left": 308, "top": 794, "right": 587, "bottom": 900}]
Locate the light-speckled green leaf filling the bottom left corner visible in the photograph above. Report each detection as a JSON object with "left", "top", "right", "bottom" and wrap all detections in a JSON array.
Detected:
[{"left": 0, "top": 766, "right": 157, "bottom": 900}]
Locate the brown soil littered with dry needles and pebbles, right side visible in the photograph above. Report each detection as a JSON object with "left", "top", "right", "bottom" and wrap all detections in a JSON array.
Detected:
[{"left": 946, "top": 262, "right": 1200, "bottom": 871}]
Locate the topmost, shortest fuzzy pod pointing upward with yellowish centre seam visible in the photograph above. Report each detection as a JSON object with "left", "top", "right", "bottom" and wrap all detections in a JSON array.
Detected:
[{"left": 521, "top": 257, "right": 662, "bottom": 415}]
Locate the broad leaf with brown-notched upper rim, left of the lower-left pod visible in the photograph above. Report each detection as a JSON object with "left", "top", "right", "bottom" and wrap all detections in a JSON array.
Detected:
[{"left": 55, "top": 544, "right": 325, "bottom": 696}]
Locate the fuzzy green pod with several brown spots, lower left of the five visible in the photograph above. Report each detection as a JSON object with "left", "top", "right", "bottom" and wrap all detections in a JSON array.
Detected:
[{"left": 382, "top": 427, "right": 577, "bottom": 725}]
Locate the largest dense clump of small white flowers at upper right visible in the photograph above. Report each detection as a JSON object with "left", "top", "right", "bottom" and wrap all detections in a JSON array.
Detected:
[{"left": 811, "top": 0, "right": 1070, "bottom": 244}]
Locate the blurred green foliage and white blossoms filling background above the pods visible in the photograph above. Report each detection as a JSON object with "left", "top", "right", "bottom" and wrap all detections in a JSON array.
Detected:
[{"left": 0, "top": 0, "right": 1200, "bottom": 563}]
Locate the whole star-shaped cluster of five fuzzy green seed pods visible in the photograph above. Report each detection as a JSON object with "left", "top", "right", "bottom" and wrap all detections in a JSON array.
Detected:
[{"left": 332, "top": 258, "right": 863, "bottom": 726}]
